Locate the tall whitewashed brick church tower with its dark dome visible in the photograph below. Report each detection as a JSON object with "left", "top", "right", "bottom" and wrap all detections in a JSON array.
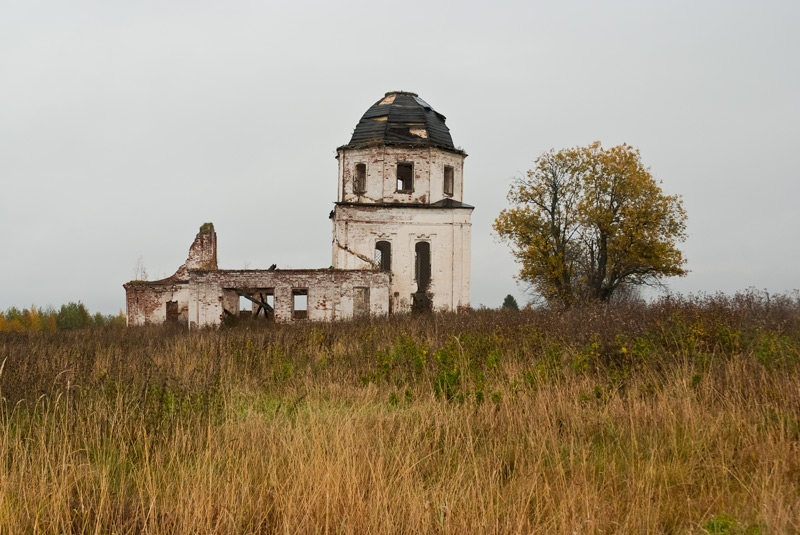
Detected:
[{"left": 331, "top": 91, "right": 473, "bottom": 312}]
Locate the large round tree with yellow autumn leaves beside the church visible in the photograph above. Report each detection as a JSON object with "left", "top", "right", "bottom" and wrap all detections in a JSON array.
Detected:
[{"left": 494, "top": 142, "right": 687, "bottom": 306}]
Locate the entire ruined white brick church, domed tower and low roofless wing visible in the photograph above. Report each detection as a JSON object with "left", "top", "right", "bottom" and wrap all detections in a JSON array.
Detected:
[{"left": 123, "top": 91, "right": 473, "bottom": 327}]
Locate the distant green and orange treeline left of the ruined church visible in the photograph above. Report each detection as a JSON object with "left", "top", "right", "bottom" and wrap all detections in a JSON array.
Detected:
[{"left": 0, "top": 301, "right": 125, "bottom": 332}]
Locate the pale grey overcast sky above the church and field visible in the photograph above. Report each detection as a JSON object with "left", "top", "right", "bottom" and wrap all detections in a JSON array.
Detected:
[{"left": 0, "top": 0, "right": 800, "bottom": 313}]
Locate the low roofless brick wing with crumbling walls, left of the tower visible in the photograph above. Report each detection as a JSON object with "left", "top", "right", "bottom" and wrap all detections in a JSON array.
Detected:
[{"left": 123, "top": 223, "right": 391, "bottom": 327}]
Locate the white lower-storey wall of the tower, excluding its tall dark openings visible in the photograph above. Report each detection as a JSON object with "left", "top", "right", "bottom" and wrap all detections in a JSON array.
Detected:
[{"left": 333, "top": 204, "right": 472, "bottom": 312}]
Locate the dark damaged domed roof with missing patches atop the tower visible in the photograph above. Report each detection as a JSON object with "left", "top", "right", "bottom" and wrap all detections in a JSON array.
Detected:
[{"left": 340, "top": 91, "right": 463, "bottom": 153}]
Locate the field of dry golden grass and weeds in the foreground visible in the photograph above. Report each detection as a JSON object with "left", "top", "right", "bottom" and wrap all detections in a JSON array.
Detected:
[{"left": 0, "top": 293, "right": 800, "bottom": 534}]
